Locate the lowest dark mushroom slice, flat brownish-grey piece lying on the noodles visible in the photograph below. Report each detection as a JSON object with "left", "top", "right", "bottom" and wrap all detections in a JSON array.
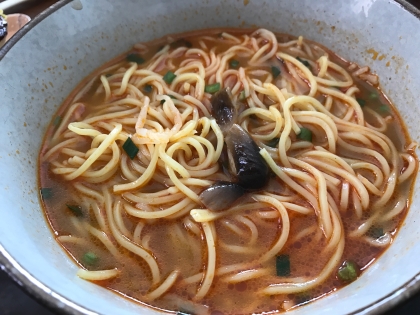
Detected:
[{"left": 200, "top": 182, "right": 245, "bottom": 211}]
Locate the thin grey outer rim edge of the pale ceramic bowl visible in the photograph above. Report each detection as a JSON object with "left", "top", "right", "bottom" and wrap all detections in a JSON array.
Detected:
[{"left": 0, "top": 0, "right": 420, "bottom": 315}]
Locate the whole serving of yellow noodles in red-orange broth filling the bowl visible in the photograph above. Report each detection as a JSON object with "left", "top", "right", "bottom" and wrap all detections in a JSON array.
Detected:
[{"left": 39, "top": 29, "right": 417, "bottom": 315}]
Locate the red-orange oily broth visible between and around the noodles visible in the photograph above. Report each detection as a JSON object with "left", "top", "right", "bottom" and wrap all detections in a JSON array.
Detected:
[{"left": 39, "top": 30, "right": 414, "bottom": 315}]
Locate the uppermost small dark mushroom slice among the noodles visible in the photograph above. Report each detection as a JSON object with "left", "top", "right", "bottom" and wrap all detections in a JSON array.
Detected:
[{"left": 210, "top": 89, "right": 237, "bottom": 134}]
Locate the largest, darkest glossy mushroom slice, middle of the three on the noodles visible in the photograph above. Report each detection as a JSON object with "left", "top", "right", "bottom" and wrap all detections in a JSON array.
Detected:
[{"left": 225, "top": 124, "right": 270, "bottom": 189}]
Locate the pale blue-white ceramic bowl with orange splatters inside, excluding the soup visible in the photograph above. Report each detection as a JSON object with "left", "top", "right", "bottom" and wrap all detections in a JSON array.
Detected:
[{"left": 0, "top": 0, "right": 420, "bottom": 315}]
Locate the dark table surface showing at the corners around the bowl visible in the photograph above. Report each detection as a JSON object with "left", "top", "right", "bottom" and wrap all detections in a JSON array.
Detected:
[{"left": 0, "top": 0, "right": 420, "bottom": 315}]
